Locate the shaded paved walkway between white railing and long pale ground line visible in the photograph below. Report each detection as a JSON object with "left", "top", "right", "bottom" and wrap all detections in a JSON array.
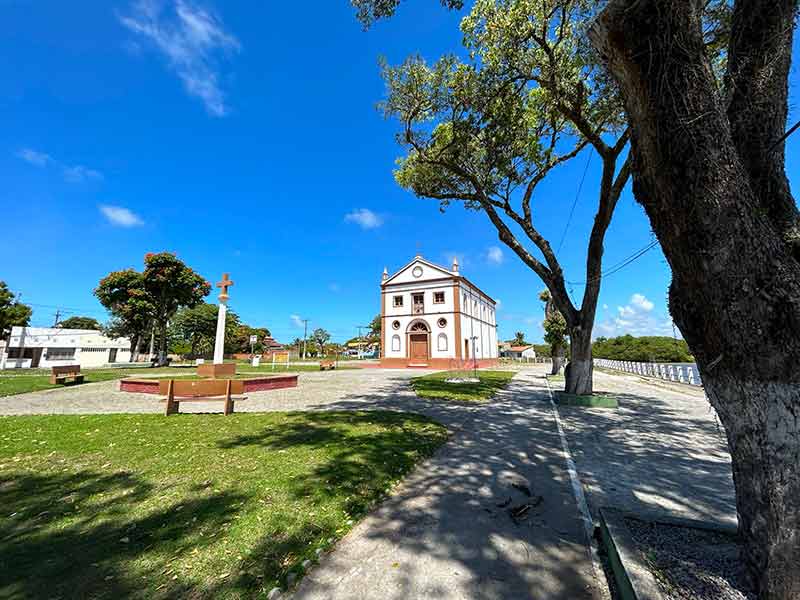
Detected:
[{"left": 559, "top": 370, "right": 737, "bottom": 526}]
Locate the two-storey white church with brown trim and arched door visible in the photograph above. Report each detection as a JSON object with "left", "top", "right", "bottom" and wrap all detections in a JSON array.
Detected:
[{"left": 381, "top": 256, "right": 497, "bottom": 369}]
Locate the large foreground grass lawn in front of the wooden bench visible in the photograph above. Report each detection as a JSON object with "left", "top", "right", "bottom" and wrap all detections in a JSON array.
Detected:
[{"left": 0, "top": 412, "right": 447, "bottom": 599}]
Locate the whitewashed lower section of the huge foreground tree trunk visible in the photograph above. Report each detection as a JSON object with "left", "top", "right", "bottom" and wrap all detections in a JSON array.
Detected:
[{"left": 702, "top": 368, "right": 800, "bottom": 600}]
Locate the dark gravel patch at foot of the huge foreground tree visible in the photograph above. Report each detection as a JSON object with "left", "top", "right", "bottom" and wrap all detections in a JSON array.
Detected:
[{"left": 625, "top": 519, "right": 755, "bottom": 600}]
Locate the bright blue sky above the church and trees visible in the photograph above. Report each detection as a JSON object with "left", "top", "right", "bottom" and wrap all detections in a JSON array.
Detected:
[{"left": 0, "top": 0, "right": 800, "bottom": 341}]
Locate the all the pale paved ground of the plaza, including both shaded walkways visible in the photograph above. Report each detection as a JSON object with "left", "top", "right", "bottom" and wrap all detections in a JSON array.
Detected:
[{"left": 0, "top": 367, "right": 736, "bottom": 600}]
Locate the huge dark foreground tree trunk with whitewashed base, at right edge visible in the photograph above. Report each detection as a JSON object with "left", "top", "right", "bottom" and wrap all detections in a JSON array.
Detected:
[{"left": 590, "top": 0, "right": 800, "bottom": 600}]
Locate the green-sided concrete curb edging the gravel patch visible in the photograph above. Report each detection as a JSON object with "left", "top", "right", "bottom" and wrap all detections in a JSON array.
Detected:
[{"left": 599, "top": 508, "right": 664, "bottom": 600}]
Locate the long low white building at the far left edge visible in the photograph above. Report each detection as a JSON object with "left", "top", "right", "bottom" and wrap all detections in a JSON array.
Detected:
[{"left": 0, "top": 327, "right": 131, "bottom": 369}]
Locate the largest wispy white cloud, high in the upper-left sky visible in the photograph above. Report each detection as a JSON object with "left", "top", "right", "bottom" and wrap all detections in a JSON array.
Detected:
[{"left": 120, "top": 0, "right": 241, "bottom": 117}]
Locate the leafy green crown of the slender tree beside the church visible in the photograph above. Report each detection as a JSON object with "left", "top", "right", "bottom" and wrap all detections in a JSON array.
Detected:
[{"left": 382, "top": 0, "right": 624, "bottom": 214}]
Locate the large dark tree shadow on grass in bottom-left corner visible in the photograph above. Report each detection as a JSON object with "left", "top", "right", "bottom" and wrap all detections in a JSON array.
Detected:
[{"left": 0, "top": 470, "right": 243, "bottom": 598}]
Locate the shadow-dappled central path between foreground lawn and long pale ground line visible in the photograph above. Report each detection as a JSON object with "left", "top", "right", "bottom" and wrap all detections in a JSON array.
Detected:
[{"left": 292, "top": 371, "right": 594, "bottom": 600}]
